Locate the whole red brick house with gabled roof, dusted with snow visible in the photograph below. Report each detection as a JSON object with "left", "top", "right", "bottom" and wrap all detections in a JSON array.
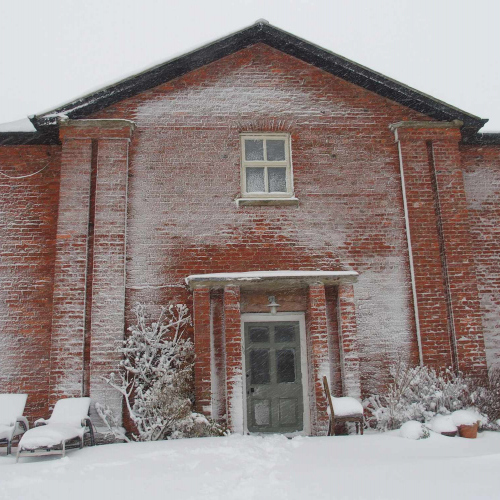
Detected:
[{"left": 0, "top": 22, "right": 500, "bottom": 434}]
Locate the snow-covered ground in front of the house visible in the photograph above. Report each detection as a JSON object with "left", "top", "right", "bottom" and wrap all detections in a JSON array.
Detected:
[{"left": 0, "top": 432, "right": 500, "bottom": 500}]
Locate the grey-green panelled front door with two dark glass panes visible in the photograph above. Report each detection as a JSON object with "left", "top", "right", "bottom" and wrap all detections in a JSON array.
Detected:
[{"left": 244, "top": 321, "right": 304, "bottom": 433}]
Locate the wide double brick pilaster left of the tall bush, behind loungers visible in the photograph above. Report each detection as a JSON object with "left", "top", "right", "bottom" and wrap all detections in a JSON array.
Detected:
[{"left": 49, "top": 120, "right": 134, "bottom": 415}]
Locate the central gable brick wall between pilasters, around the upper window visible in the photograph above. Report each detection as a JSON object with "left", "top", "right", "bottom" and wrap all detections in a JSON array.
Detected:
[{"left": 94, "top": 45, "right": 425, "bottom": 391}]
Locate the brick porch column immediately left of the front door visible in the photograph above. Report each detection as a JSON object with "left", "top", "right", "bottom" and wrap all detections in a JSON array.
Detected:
[{"left": 224, "top": 285, "right": 244, "bottom": 434}]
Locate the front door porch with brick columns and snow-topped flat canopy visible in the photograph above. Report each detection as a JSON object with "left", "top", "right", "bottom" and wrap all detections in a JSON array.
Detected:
[{"left": 185, "top": 270, "right": 360, "bottom": 435}]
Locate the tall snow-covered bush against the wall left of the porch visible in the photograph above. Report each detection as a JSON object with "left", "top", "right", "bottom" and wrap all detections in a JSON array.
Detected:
[{"left": 98, "top": 304, "right": 222, "bottom": 441}]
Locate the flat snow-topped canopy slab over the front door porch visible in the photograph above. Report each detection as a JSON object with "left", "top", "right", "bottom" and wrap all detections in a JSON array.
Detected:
[{"left": 186, "top": 271, "right": 358, "bottom": 289}]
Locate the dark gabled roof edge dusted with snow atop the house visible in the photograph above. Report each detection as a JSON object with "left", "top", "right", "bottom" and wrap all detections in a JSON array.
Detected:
[{"left": 1, "top": 20, "right": 488, "bottom": 142}]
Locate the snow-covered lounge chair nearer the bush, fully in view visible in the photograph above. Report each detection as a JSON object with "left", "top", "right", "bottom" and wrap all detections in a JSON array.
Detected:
[{"left": 16, "top": 398, "right": 95, "bottom": 463}]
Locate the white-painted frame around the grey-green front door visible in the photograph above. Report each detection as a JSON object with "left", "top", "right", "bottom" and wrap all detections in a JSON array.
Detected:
[{"left": 241, "top": 312, "right": 311, "bottom": 436}]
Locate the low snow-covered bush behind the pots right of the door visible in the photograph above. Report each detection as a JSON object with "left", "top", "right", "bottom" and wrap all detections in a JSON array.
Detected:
[{"left": 364, "top": 362, "right": 470, "bottom": 431}]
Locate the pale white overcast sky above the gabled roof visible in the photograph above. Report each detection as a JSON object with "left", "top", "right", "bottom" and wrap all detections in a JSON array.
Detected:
[{"left": 0, "top": 0, "right": 500, "bottom": 131}]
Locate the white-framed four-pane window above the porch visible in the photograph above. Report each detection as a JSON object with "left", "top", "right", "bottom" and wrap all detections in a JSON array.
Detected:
[{"left": 241, "top": 133, "right": 293, "bottom": 198}]
